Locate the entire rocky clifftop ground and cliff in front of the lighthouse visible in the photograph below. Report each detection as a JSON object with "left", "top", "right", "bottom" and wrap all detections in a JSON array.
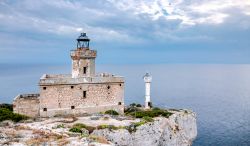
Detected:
[{"left": 0, "top": 110, "right": 197, "bottom": 146}]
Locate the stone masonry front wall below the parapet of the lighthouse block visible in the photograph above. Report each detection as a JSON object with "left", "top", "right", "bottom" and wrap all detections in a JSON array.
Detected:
[{"left": 40, "top": 83, "right": 124, "bottom": 117}]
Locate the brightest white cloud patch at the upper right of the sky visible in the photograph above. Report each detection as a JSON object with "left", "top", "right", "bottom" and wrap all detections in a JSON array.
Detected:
[{"left": 109, "top": 0, "right": 250, "bottom": 25}]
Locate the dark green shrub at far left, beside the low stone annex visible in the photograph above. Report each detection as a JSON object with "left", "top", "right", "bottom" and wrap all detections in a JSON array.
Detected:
[{"left": 0, "top": 108, "right": 28, "bottom": 122}]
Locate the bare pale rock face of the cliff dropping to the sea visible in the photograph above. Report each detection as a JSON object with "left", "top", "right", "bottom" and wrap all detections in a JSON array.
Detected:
[{"left": 92, "top": 111, "right": 197, "bottom": 146}]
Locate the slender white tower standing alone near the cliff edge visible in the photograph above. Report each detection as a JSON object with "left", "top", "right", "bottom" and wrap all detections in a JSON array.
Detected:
[{"left": 143, "top": 73, "right": 152, "bottom": 109}]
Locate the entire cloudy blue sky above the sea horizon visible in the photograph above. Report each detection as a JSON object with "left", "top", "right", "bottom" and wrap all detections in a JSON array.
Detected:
[{"left": 0, "top": 0, "right": 250, "bottom": 64}]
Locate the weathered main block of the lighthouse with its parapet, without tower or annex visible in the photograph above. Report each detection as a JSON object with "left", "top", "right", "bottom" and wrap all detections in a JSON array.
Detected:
[{"left": 40, "top": 76, "right": 124, "bottom": 117}]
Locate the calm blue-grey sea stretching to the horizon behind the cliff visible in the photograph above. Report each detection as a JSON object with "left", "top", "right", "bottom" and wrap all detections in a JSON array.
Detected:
[{"left": 0, "top": 64, "right": 250, "bottom": 146}]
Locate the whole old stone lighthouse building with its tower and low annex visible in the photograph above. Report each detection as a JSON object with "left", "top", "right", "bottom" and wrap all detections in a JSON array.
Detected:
[{"left": 13, "top": 33, "right": 124, "bottom": 117}]
